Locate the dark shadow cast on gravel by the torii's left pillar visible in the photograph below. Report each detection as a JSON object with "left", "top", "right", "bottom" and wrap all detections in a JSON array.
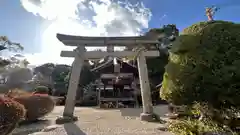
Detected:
[{"left": 64, "top": 123, "right": 87, "bottom": 135}]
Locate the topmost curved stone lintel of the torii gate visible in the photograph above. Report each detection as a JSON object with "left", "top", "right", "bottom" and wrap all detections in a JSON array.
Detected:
[{"left": 57, "top": 33, "right": 159, "bottom": 46}]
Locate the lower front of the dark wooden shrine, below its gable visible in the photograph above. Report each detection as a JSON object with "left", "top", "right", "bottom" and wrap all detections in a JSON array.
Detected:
[{"left": 97, "top": 73, "right": 138, "bottom": 108}]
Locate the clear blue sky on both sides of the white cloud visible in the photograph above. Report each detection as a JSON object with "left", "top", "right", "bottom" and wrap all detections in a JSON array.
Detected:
[{"left": 0, "top": 0, "right": 240, "bottom": 65}]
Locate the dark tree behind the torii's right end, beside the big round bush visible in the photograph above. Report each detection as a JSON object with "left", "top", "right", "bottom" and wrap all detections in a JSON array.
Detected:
[{"left": 125, "top": 24, "right": 179, "bottom": 85}]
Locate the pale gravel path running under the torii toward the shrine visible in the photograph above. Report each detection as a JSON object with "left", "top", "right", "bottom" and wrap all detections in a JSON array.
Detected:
[{"left": 13, "top": 105, "right": 171, "bottom": 135}]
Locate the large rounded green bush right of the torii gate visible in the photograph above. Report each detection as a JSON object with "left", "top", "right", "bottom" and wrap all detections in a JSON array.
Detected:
[{"left": 160, "top": 21, "right": 240, "bottom": 110}]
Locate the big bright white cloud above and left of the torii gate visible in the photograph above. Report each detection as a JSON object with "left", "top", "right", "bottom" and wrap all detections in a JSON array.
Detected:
[{"left": 21, "top": 0, "right": 151, "bottom": 65}]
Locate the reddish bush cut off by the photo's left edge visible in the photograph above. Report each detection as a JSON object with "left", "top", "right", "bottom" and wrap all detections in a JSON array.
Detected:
[{"left": 0, "top": 97, "right": 26, "bottom": 135}]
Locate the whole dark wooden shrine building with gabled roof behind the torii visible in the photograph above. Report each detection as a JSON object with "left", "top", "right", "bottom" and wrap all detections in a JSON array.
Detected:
[{"left": 94, "top": 61, "right": 140, "bottom": 108}]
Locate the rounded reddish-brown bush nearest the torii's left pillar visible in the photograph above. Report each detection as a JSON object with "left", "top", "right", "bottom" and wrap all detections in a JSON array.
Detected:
[{"left": 14, "top": 94, "right": 55, "bottom": 121}]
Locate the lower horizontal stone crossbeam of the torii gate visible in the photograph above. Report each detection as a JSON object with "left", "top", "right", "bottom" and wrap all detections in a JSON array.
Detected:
[{"left": 60, "top": 51, "right": 160, "bottom": 59}]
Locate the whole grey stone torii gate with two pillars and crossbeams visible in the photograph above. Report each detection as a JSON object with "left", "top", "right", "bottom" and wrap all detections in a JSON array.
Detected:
[{"left": 57, "top": 34, "right": 160, "bottom": 123}]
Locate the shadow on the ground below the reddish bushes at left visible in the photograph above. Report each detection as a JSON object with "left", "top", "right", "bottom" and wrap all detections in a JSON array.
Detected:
[{"left": 12, "top": 120, "right": 52, "bottom": 135}]
